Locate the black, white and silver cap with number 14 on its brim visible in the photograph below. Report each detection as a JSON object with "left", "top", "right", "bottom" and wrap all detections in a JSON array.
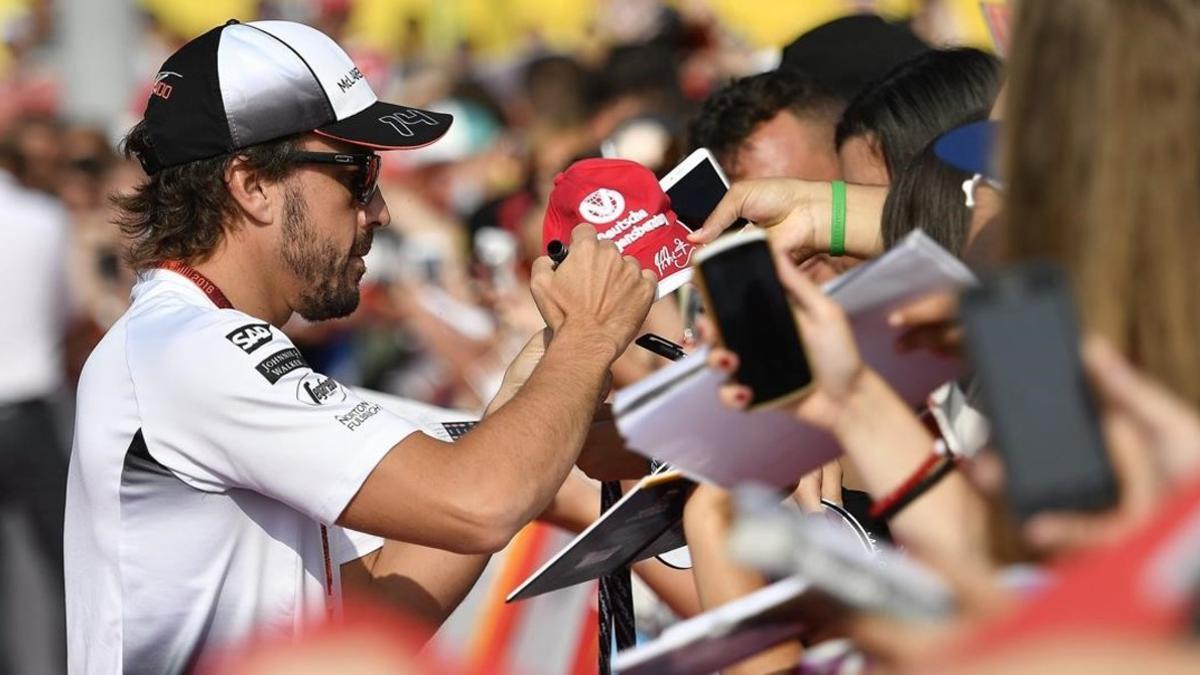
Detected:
[{"left": 139, "top": 20, "right": 454, "bottom": 173}]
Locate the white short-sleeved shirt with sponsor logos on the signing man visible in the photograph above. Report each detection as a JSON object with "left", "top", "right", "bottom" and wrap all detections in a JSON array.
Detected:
[{"left": 65, "top": 270, "right": 416, "bottom": 674}]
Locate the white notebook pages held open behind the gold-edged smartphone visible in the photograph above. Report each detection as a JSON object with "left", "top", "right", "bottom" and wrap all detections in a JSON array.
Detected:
[{"left": 613, "top": 231, "right": 974, "bottom": 488}]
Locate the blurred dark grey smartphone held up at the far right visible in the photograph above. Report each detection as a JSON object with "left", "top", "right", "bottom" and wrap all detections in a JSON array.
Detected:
[{"left": 960, "top": 262, "right": 1117, "bottom": 520}]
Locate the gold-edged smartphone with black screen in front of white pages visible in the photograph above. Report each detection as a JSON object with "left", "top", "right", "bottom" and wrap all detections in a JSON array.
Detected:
[{"left": 694, "top": 231, "right": 812, "bottom": 408}]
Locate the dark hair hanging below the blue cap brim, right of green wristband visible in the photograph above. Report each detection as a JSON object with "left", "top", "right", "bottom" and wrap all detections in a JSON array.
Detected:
[{"left": 882, "top": 135, "right": 971, "bottom": 256}]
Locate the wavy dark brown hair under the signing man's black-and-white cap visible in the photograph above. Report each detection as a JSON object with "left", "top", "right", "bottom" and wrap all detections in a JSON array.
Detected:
[{"left": 112, "top": 121, "right": 296, "bottom": 270}]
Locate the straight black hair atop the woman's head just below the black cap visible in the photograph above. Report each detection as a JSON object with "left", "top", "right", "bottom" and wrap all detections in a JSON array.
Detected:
[{"left": 836, "top": 48, "right": 1001, "bottom": 179}]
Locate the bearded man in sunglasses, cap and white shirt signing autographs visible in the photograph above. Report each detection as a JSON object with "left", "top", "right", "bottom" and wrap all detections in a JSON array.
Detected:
[{"left": 65, "top": 22, "right": 655, "bottom": 674}]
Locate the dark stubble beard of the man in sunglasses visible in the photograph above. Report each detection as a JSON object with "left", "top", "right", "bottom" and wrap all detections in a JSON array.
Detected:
[{"left": 280, "top": 186, "right": 370, "bottom": 321}]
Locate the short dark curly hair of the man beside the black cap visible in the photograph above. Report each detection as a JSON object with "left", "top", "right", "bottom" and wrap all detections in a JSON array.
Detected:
[{"left": 688, "top": 71, "right": 841, "bottom": 166}]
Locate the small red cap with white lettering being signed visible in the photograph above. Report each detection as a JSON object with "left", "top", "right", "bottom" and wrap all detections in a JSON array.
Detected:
[{"left": 541, "top": 160, "right": 695, "bottom": 297}]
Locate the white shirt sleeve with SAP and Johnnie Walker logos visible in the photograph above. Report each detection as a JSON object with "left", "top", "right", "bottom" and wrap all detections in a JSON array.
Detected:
[{"left": 127, "top": 306, "right": 416, "bottom": 524}]
